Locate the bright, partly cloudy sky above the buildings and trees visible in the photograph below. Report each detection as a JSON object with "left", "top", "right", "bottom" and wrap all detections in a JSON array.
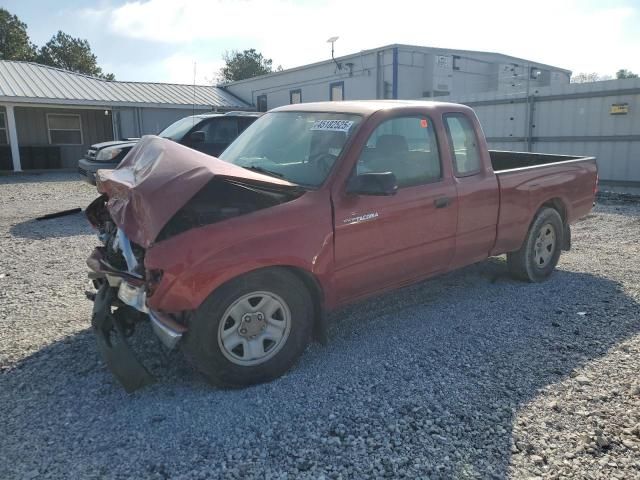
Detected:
[{"left": 2, "top": 0, "right": 640, "bottom": 84}]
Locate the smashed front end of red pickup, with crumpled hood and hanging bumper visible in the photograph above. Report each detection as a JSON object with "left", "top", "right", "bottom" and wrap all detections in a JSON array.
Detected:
[{"left": 86, "top": 136, "right": 304, "bottom": 392}]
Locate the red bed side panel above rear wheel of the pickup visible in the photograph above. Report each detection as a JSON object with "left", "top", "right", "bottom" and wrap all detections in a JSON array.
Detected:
[{"left": 491, "top": 158, "right": 597, "bottom": 255}]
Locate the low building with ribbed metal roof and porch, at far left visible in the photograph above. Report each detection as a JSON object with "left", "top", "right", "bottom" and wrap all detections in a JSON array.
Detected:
[{"left": 0, "top": 61, "right": 251, "bottom": 172}]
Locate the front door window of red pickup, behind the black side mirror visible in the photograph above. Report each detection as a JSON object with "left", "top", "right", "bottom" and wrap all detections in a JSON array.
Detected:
[{"left": 357, "top": 116, "right": 442, "bottom": 188}]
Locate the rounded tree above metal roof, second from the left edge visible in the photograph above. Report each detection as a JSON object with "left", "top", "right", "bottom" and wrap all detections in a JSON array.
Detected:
[{"left": 37, "top": 31, "right": 115, "bottom": 80}]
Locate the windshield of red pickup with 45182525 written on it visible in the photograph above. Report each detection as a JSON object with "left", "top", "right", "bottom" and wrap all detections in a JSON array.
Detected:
[{"left": 220, "top": 112, "right": 361, "bottom": 187}]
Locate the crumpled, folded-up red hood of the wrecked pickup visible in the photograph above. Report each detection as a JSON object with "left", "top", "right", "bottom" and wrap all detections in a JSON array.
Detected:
[{"left": 96, "top": 135, "right": 299, "bottom": 248}]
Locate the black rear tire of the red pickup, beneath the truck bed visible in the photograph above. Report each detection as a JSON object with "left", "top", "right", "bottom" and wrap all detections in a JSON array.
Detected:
[{"left": 507, "top": 208, "right": 565, "bottom": 282}]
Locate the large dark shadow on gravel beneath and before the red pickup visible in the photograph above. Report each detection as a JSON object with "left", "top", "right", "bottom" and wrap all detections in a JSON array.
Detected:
[{"left": 0, "top": 259, "right": 640, "bottom": 478}]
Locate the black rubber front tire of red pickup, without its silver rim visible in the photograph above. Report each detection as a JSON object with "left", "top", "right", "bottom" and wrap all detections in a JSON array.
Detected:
[{"left": 183, "top": 268, "right": 314, "bottom": 388}]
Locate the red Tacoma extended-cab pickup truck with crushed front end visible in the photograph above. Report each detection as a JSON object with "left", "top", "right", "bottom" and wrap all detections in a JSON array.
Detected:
[{"left": 87, "top": 101, "right": 597, "bottom": 390}]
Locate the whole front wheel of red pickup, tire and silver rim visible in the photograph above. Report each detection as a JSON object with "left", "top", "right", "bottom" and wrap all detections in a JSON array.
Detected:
[{"left": 184, "top": 268, "right": 313, "bottom": 387}]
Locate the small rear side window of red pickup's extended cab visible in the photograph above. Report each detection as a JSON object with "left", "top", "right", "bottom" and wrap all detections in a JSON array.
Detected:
[{"left": 443, "top": 113, "right": 482, "bottom": 177}]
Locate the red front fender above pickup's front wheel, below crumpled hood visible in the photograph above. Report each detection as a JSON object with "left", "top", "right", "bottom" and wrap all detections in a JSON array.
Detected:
[{"left": 145, "top": 192, "right": 333, "bottom": 312}]
